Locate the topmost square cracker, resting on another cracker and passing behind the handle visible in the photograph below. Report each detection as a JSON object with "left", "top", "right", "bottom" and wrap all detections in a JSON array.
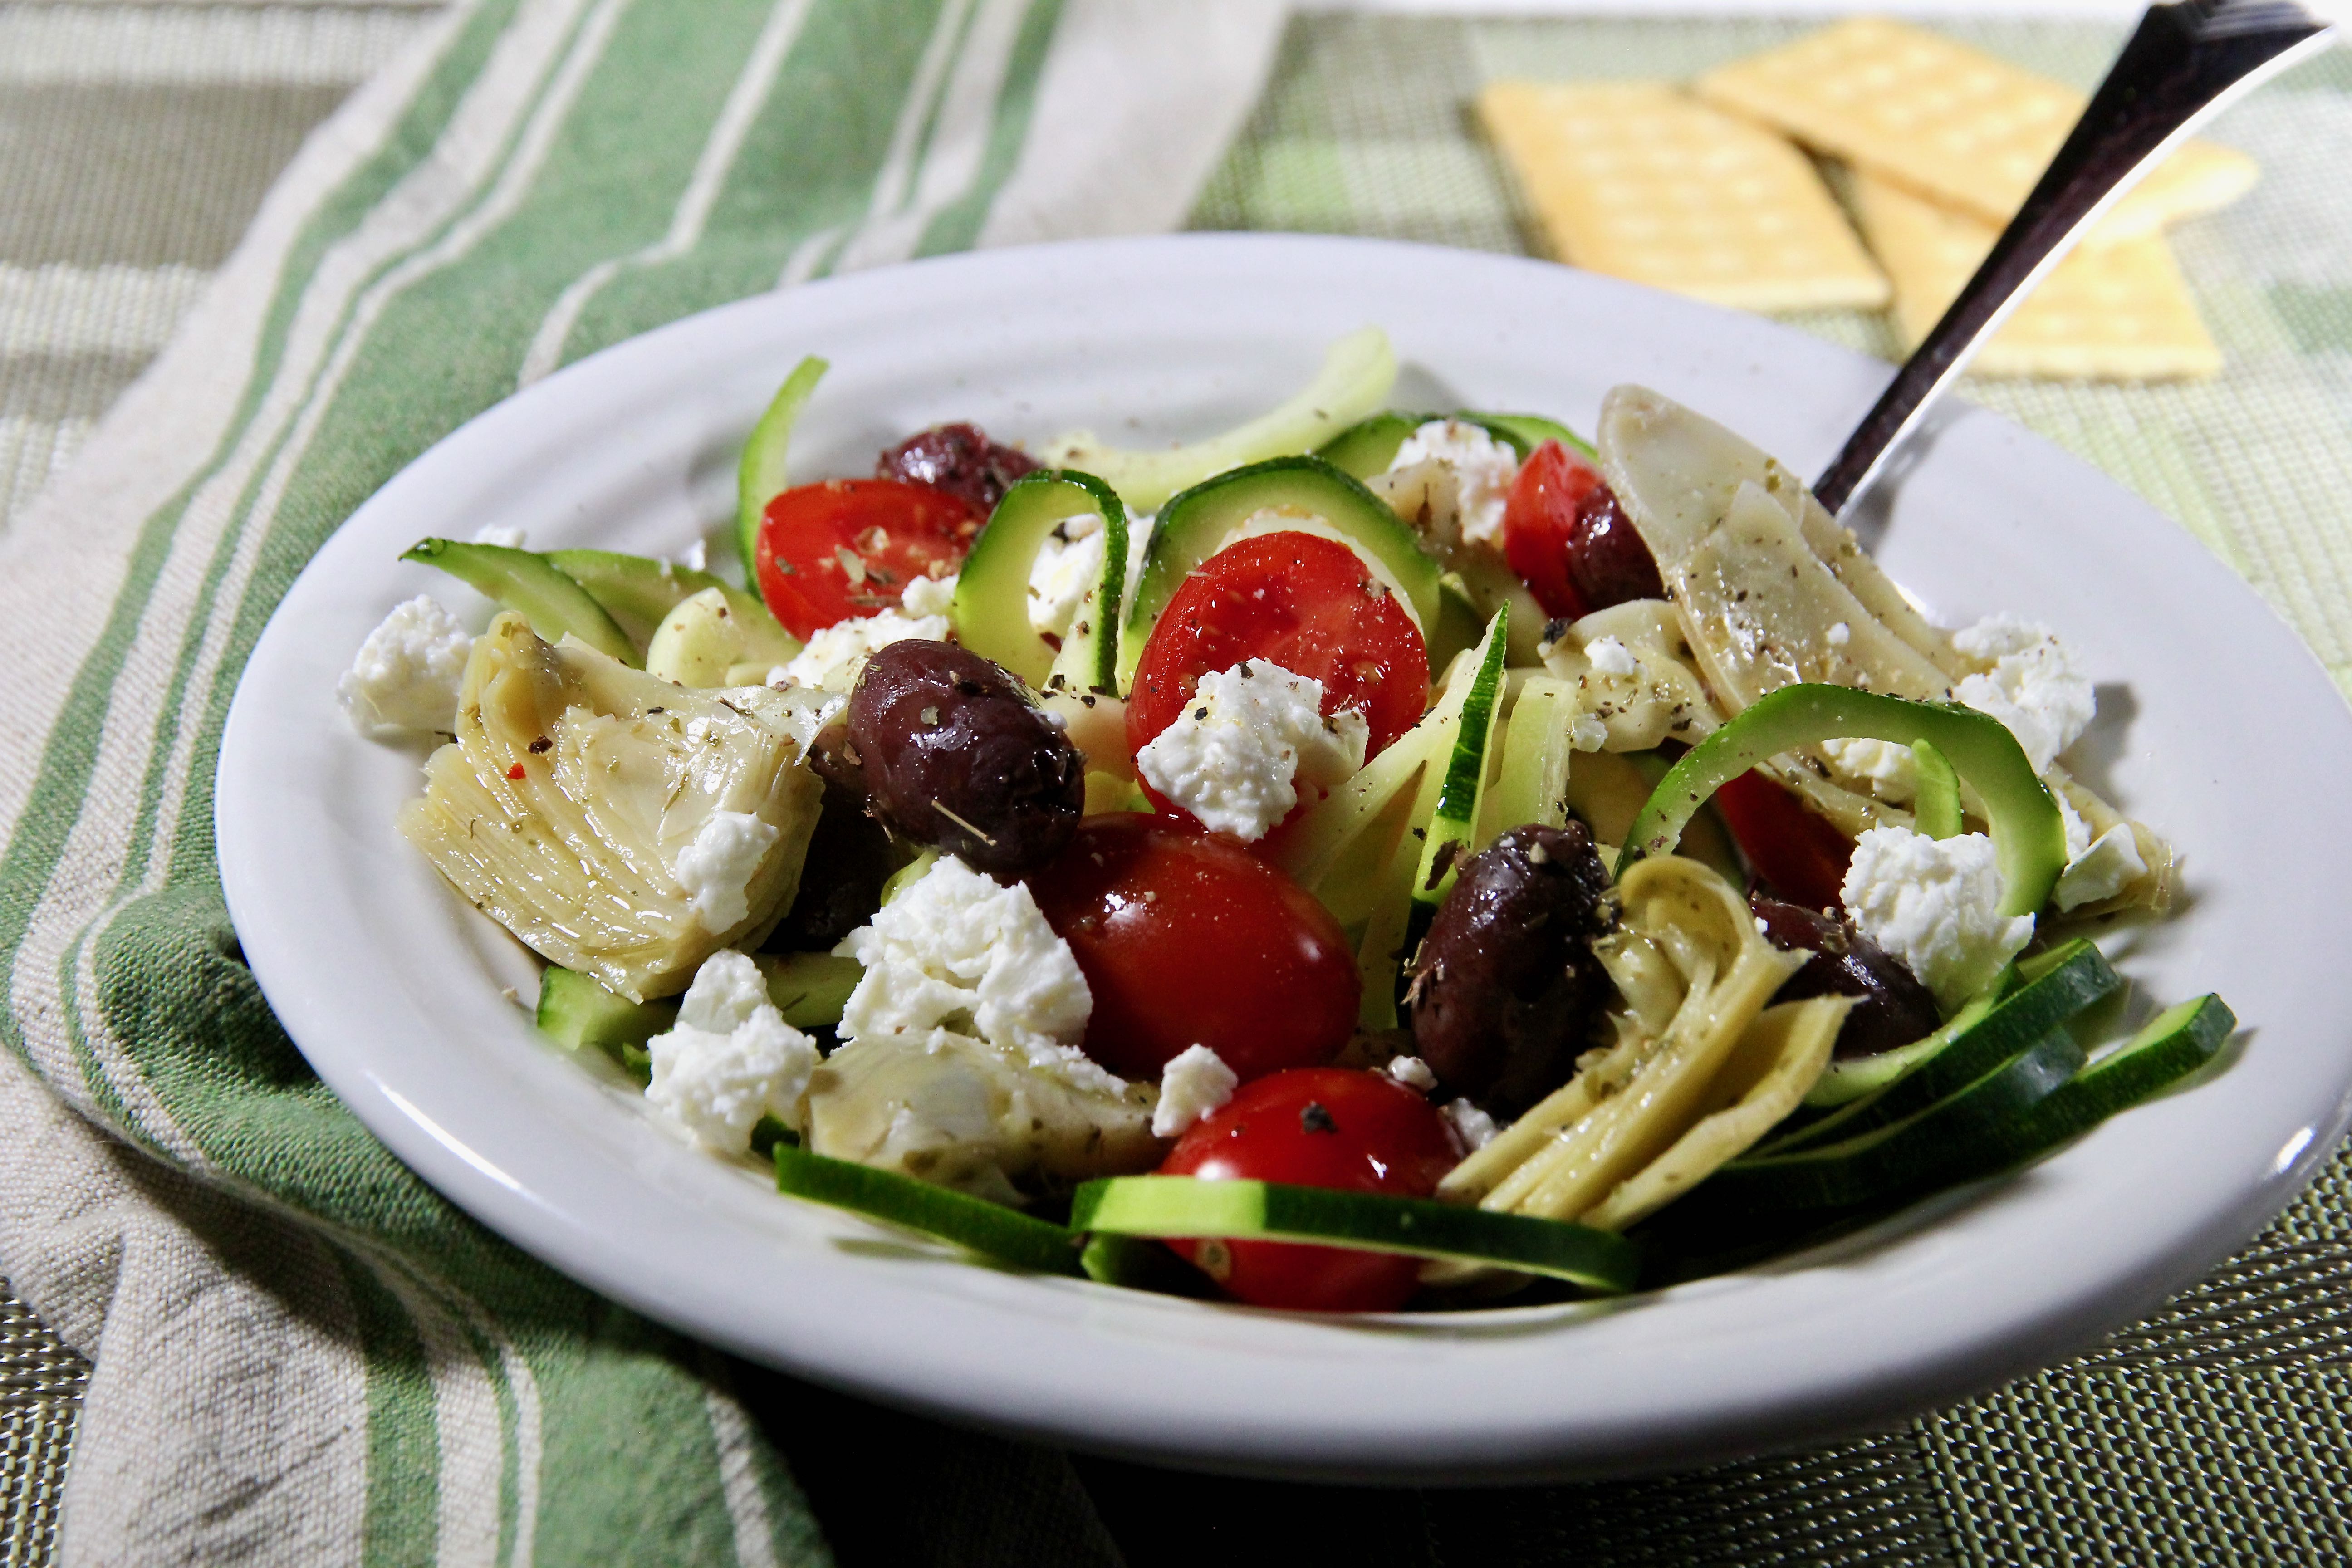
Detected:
[{"left": 1693, "top": 16, "right": 2260, "bottom": 245}]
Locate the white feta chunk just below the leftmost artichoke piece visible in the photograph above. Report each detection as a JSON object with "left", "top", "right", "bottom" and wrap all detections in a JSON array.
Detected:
[{"left": 644, "top": 950, "right": 816, "bottom": 1154}]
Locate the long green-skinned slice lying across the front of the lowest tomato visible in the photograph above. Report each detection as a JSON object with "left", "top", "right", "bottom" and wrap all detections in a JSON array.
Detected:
[{"left": 1070, "top": 1176, "right": 1639, "bottom": 1293}]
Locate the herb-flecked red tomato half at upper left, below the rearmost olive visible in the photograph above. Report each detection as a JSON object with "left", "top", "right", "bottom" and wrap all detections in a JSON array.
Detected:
[{"left": 753, "top": 480, "right": 985, "bottom": 639}]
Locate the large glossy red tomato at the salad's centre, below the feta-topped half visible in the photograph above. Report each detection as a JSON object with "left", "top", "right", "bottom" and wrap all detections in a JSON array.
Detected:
[{"left": 1030, "top": 811, "right": 1362, "bottom": 1081}]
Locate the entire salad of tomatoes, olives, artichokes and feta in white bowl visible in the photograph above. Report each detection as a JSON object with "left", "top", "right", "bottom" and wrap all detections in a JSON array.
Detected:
[{"left": 341, "top": 329, "right": 2234, "bottom": 1312}]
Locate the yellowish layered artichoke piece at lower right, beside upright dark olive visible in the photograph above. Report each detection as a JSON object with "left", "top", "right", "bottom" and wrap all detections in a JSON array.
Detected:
[{"left": 1440, "top": 856, "right": 1816, "bottom": 1227}]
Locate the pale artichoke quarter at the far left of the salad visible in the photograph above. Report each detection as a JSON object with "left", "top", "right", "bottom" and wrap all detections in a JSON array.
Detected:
[{"left": 400, "top": 613, "right": 838, "bottom": 1001}]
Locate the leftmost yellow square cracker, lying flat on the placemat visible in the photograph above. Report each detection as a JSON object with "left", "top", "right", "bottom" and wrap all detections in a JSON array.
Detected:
[{"left": 1477, "top": 82, "right": 1886, "bottom": 310}]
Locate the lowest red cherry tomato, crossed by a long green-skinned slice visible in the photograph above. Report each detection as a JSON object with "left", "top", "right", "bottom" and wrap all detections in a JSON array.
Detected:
[{"left": 1160, "top": 1067, "right": 1458, "bottom": 1312}]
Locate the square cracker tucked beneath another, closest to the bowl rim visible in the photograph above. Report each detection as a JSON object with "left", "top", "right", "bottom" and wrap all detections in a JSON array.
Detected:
[{"left": 1853, "top": 172, "right": 2220, "bottom": 381}]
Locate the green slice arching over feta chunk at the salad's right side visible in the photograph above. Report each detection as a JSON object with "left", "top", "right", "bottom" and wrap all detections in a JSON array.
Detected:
[{"left": 1618, "top": 684, "right": 2065, "bottom": 915}]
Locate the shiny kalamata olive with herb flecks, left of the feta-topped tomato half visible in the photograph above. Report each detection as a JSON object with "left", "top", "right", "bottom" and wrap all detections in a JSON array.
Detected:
[{"left": 847, "top": 637, "right": 1087, "bottom": 877}]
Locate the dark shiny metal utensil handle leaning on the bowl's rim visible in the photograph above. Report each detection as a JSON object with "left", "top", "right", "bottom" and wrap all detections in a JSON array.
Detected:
[{"left": 1813, "top": 0, "right": 2331, "bottom": 513}]
